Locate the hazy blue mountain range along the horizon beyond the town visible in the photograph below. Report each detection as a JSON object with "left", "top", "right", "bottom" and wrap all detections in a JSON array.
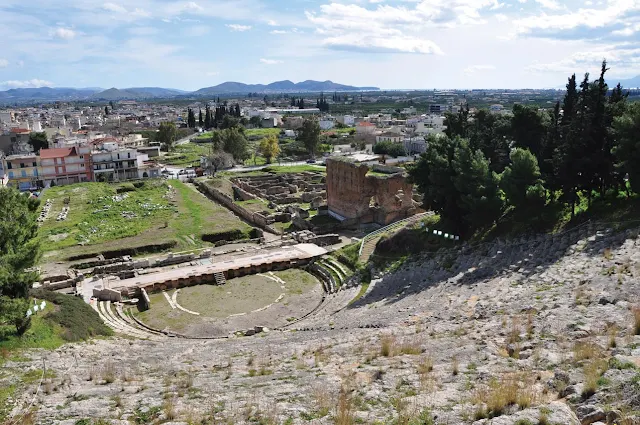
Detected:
[{"left": 0, "top": 80, "right": 380, "bottom": 104}]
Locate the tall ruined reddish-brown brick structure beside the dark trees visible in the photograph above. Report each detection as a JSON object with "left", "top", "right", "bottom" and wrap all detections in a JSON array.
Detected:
[{"left": 327, "top": 159, "right": 418, "bottom": 225}]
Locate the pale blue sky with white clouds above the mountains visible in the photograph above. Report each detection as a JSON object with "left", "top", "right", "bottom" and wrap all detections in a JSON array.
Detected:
[{"left": 0, "top": 0, "right": 640, "bottom": 90}]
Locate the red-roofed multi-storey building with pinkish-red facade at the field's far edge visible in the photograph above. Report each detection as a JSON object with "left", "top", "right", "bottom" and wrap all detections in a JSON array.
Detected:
[{"left": 40, "top": 146, "right": 93, "bottom": 187}]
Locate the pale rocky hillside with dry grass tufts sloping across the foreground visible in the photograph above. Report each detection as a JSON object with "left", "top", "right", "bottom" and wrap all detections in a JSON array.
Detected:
[{"left": 0, "top": 225, "right": 640, "bottom": 425}]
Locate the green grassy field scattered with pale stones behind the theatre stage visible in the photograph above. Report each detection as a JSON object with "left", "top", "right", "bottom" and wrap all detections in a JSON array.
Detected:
[{"left": 39, "top": 180, "right": 250, "bottom": 257}]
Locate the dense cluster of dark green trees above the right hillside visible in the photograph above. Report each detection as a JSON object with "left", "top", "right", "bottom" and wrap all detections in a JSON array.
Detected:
[{"left": 410, "top": 61, "right": 640, "bottom": 232}]
